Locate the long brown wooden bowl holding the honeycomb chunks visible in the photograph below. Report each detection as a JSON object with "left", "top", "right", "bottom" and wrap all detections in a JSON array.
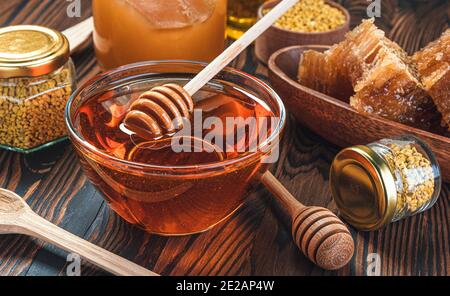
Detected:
[{"left": 269, "top": 45, "right": 450, "bottom": 182}]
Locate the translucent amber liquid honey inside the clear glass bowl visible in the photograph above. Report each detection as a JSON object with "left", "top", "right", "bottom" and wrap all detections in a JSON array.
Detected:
[{"left": 70, "top": 75, "right": 274, "bottom": 235}]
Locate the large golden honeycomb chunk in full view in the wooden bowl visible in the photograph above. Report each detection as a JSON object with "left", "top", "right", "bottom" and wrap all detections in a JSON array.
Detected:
[{"left": 299, "top": 20, "right": 431, "bottom": 125}]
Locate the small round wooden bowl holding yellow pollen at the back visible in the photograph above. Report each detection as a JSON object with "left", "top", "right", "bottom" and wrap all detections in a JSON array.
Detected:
[{"left": 255, "top": 0, "right": 350, "bottom": 64}]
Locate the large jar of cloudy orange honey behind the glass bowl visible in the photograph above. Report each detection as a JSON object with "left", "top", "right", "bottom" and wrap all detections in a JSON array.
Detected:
[{"left": 92, "top": 0, "right": 227, "bottom": 69}]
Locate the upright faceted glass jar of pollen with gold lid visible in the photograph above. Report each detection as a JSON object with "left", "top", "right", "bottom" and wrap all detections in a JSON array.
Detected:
[{"left": 0, "top": 25, "right": 76, "bottom": 153}]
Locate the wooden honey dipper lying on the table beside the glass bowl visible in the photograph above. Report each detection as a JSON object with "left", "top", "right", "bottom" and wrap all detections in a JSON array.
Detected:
[{"left": 261, "top": 172, "right": 355, "bottom": 270}]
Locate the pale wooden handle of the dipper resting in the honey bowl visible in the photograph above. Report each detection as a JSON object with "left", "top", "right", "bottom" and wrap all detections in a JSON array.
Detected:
[{"left": 184, "top": 0, "right": 298, "bottom": 96}]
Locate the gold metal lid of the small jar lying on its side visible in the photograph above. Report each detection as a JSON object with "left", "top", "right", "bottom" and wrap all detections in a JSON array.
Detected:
[{"left": 330, "top": 146, "right": 397, "bottom": 230}]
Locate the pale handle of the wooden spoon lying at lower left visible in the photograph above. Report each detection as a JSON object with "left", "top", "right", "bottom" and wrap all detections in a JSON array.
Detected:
[{"left": 17, "top": 211, "right": 158, "bottom": 276}]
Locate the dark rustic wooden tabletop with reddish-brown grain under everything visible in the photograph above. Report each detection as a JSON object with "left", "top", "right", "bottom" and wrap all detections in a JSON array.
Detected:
[{"left": 0, "top": 0, "right": 450, "bottom": 275}]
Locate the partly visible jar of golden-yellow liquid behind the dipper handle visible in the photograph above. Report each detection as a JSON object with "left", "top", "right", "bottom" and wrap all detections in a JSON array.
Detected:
[{"left": 227, "top": 0, "right": 266, "bottom": 39}]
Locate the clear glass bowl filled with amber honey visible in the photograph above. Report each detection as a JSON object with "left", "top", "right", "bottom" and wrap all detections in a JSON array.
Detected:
[{"left": 66, "top": 61, "right": 286, "bottom": 235}]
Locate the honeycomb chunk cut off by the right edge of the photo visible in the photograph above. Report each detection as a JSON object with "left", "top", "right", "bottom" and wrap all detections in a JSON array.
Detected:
[{"left": 413, "top": 29, "right": 450, "bottom": 130}]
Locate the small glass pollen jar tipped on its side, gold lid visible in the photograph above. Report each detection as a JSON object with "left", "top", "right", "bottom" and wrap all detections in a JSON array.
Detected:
[{"left": 330, "top": 135, "right": 442, "bottom": 230}]
